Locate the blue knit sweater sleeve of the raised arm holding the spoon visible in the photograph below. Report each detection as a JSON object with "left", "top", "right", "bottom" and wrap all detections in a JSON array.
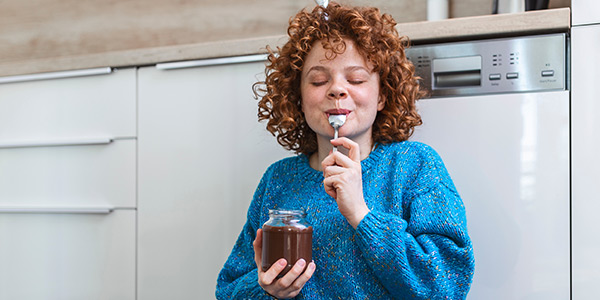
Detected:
[{"left": 357, "top": 145, "right": 474, "bottom": 299}]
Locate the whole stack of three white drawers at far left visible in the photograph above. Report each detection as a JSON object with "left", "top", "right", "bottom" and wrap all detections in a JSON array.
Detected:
[{"left": 0, "top": 69, "right": 137, "bottom": 300}]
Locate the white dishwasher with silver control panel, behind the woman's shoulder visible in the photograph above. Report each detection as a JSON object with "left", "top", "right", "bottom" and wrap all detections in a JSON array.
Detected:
[{"left": 406, "top": 33, "right": 571, "bottom": 300}]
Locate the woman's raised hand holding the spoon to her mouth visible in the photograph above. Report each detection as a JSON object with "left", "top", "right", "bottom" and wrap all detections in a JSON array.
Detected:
[{"left": 321, "top": 137, "right": 369, "bottom": 228}]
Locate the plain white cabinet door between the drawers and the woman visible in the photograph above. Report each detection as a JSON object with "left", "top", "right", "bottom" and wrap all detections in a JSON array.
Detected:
[{"left": 138, "top": 63, "right": 289, "bottom": 300}]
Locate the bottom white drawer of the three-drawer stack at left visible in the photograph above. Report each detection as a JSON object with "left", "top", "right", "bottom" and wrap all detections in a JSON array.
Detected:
[{"left": 0, "top": 210, "right": 136, "bottom": 300}]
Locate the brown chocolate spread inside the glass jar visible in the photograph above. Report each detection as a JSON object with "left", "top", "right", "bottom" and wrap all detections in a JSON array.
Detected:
[{"left": 262, "top": 210, "right": 313, "bottom": 278}]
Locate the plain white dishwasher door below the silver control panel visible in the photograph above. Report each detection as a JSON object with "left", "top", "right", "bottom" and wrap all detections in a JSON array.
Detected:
[{"left": 413, "top": 91, "right": 570, "bottom": 300}]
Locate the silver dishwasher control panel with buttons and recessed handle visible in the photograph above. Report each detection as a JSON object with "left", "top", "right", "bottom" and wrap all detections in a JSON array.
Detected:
[{"left": 406, "top": 33, "right": 567, "bottom": 97}]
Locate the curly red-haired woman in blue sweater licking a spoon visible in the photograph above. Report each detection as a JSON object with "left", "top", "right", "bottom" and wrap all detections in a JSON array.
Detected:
[{"left": 216, "top": 3, "right": 474, "bottom": 299}]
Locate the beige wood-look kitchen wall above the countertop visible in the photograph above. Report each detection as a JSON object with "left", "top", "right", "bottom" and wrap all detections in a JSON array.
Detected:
[{"left": 0, "top": 0, "right": 570, "bottom": 69}]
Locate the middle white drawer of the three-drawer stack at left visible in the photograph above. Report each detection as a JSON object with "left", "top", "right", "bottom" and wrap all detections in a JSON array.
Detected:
[{"left": 0, "top": 139, "right": 136, "bottom": 207}]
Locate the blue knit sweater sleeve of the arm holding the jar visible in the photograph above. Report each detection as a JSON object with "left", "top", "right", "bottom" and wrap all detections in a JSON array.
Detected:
[{"left": 215, "top": 170, "right": 273, "bottom": 299}]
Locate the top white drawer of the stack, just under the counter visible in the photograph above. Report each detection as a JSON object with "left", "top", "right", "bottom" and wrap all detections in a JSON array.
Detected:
[{"left": 0, "top": 69, "right": 136, "bottom": 146}]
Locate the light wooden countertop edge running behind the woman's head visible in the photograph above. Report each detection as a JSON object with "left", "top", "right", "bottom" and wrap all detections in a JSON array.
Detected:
[{"left": 0, "top": 8, "right": 571, "bottom": 76}]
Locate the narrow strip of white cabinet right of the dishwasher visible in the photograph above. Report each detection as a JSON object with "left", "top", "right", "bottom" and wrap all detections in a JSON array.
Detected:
[{"left": 571, "top": 25, "right": 600, "bottom": 300}]
